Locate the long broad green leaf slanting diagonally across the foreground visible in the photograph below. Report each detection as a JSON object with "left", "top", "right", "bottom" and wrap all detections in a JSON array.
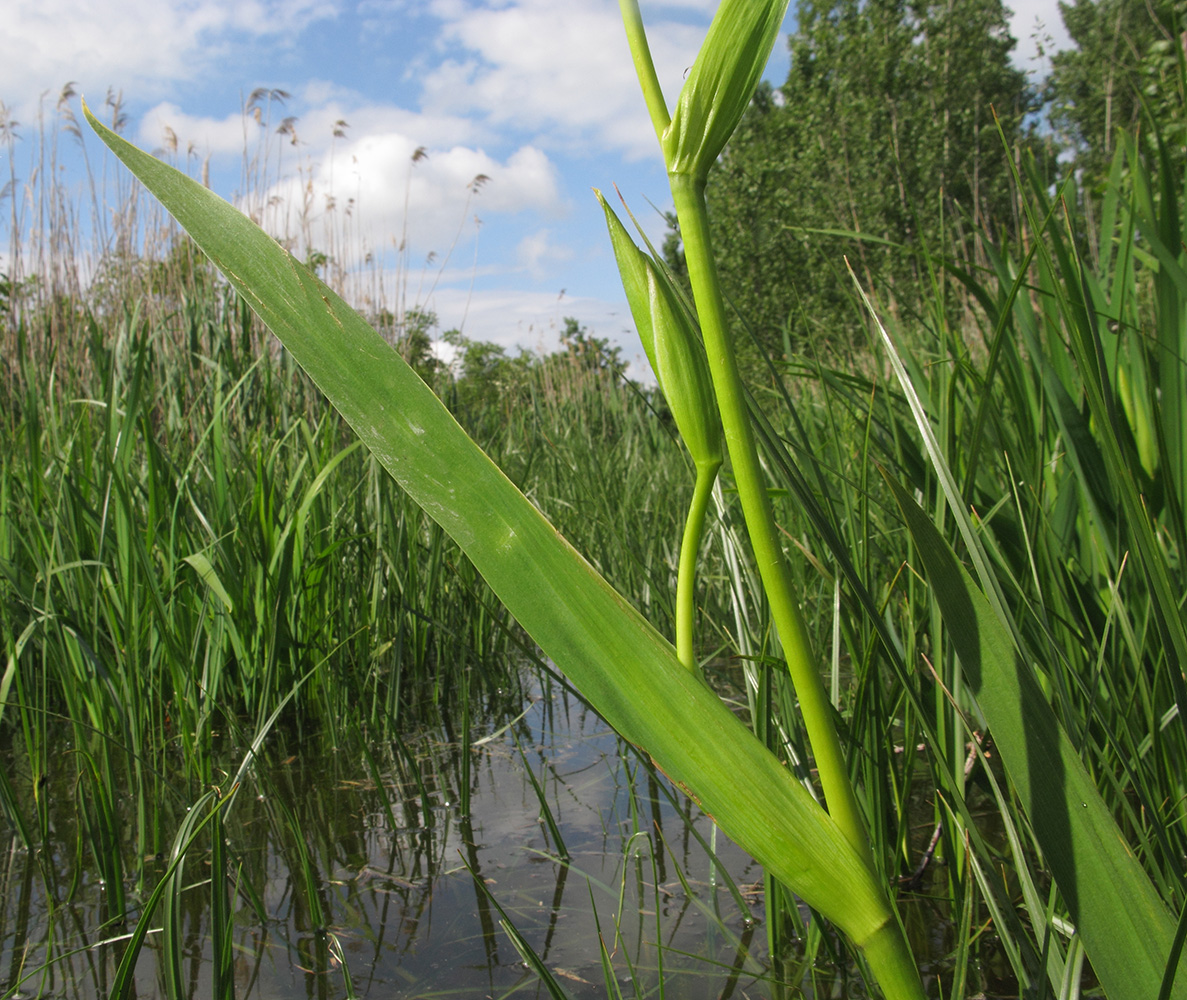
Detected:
[{"left": 84, "top": 99, "right": 921, "bottom": 998}]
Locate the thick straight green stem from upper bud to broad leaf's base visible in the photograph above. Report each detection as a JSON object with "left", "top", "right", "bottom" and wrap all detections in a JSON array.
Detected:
[{"left": 669, "top": 171, "right": 874, "bottom": 871}]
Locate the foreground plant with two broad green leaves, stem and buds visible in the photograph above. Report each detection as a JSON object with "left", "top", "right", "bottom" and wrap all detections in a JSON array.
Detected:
[{"left": 74, "top": 0, "right": 1187, "bottom": 1000}]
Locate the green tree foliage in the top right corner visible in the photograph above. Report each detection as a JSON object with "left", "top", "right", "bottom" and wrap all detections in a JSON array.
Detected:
[{"left": 1047, "top": 0, "right": 1187, "bottom": 189}]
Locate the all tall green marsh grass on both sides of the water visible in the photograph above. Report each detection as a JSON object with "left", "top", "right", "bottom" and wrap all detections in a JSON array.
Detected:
[{"left": 0, "top": 13, "right": 1187, "bottom": 998}]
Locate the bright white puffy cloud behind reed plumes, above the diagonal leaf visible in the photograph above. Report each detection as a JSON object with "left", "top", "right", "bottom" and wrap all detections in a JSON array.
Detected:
[{"left": 129, "top": 82, "right": 567, "bottom": 257}]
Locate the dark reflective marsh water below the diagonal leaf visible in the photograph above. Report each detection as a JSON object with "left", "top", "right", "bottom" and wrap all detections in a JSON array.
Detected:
[{"left": 0, "top": 675, "right": 770, "bottom": 1000}]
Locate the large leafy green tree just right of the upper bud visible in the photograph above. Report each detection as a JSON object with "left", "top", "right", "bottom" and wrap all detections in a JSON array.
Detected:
[{"left": 668, "top": 0, "right": 1035, "bottom": 350}]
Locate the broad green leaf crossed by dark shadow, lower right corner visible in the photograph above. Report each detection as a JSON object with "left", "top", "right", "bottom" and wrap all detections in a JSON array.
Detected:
[{"left": 886, "top": 476, "right": 1187, "bottom": 1000}]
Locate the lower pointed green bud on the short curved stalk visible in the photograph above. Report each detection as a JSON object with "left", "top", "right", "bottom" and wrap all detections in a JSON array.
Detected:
[{"left": 594, "top": 191, "right": 724, "bottom": 469}]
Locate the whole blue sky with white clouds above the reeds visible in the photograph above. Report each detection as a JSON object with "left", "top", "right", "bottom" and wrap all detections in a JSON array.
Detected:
[{"left": 0, "top": 0, "right": 1066, "bottom": 370}]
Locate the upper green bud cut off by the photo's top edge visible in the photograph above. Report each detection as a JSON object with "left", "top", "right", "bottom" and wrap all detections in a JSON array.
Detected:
[{"left": 660, "top": 0, "right": 788, "bottom": 181}]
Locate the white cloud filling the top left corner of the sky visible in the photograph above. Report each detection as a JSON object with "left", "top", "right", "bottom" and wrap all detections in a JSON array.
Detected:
[{"left": 0, "top": 0, "right": 341, "bottom": 114}]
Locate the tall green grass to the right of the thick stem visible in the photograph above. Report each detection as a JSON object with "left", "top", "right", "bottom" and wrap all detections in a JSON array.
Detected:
[{"left": 726, "top": 120, "right": 1187, "bottom": 996}]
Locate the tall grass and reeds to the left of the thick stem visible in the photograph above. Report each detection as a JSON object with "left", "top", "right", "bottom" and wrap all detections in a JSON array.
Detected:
[{"left": 0, "top": 85, "right": 754, "bottom": 995}]
